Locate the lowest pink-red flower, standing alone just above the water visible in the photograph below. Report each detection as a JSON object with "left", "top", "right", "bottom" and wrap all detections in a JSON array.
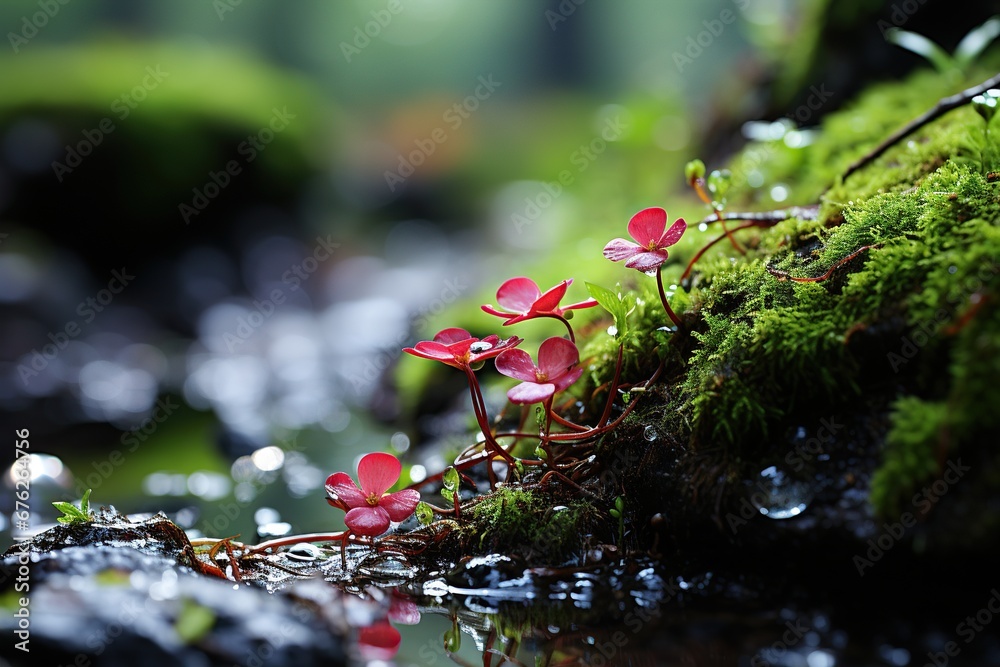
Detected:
[{"left": 326, "top": 452, "right": 420, "bottom": 536}]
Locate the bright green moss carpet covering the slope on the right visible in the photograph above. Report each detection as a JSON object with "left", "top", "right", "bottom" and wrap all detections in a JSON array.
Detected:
[{"left": 592, "top": 65, "right": 1000, "bottom": 513}]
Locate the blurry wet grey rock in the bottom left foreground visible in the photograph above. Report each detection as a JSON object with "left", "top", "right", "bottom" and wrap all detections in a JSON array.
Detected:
[{"left": 0, "top": 514, "right": 346, "bottom": 667}]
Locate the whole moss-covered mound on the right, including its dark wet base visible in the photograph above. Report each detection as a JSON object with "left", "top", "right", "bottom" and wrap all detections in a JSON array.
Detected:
[{"left": 434, "top": 65, "right": 1000, "bottom": 567}]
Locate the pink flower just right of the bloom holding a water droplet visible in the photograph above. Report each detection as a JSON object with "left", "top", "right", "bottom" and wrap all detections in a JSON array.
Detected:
[{"left": 496, "top": 338, "right": 583, "bottom": 404}]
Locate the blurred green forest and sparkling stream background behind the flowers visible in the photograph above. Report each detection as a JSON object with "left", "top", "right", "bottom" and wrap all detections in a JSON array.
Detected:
[{"left": 0, "top": 0, "right": 998, "bottom": 596}]
